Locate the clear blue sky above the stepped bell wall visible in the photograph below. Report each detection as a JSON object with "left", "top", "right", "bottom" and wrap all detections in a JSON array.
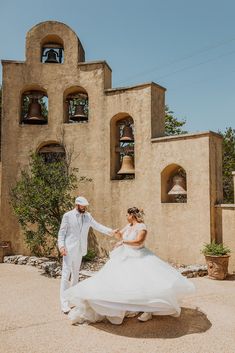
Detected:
[{"left": 0, "top": 0, "right": 235, "bottom": 132}]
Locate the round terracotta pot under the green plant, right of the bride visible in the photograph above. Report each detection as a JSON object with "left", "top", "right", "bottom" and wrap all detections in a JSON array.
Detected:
[{"left": 205, "top": 255, "right": 230, "bottom": 280}]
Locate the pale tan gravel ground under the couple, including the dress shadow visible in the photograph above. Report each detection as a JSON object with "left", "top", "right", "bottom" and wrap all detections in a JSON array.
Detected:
[{"left": 0, "top": 263, "right": 235, "bottom": 353}]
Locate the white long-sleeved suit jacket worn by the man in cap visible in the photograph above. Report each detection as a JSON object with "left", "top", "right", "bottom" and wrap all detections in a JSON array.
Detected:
[{"left": 58, "top": 208, "right": 112, "bottom": 256}]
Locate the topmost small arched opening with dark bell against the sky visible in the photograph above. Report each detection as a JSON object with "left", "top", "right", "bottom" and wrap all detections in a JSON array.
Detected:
[{"left": 41, "top": 35, "right": 64, "bottom": 64}]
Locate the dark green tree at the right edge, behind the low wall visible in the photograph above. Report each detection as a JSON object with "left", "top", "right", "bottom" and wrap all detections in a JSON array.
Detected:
[{"left": 220, "top": 127, "right": 235, "bottom": 203}]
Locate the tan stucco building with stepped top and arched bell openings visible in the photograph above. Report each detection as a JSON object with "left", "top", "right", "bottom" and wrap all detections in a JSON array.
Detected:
[{"left": 0, "top": 21, "right": 235, "bottom": 264}]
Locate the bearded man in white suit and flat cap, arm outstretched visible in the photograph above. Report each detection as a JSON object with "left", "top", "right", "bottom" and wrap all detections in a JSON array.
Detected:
[{"left": 58, "top": 196, "right": 114, "bottom": 314}]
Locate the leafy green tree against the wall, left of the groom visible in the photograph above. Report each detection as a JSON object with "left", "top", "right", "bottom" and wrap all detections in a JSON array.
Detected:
[{"left": 11, "top": 154, "right": 90, "bottom": 256}]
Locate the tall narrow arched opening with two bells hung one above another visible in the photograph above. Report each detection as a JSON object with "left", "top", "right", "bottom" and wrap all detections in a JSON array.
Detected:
[{"left": 110, "top": 113, "right": 135, "bottom": 180}]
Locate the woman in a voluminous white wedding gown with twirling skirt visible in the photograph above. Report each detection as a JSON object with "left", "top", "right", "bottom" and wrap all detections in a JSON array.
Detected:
[{"left": 65, "top": 207, "right": 195, "bottom": 325}]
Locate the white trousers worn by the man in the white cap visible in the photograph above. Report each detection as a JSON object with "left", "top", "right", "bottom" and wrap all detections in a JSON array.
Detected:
[{"left": 60, "top": 253, "right": 82, "bottom": 310}]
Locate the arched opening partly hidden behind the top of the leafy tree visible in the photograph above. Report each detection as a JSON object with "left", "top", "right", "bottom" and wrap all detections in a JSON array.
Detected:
[{"left": 37, "top": 142, "right": 66, "bottom": 163}]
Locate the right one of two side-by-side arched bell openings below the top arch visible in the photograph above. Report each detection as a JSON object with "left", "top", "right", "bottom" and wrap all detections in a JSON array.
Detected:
[{"left": 64, "top": 87, "right": 89, "bottom": 124}]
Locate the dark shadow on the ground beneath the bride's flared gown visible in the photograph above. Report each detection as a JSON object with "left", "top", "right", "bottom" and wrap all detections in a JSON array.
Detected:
[{"left": 93, "top": 308, "right": 211, "bottom": 338}]
